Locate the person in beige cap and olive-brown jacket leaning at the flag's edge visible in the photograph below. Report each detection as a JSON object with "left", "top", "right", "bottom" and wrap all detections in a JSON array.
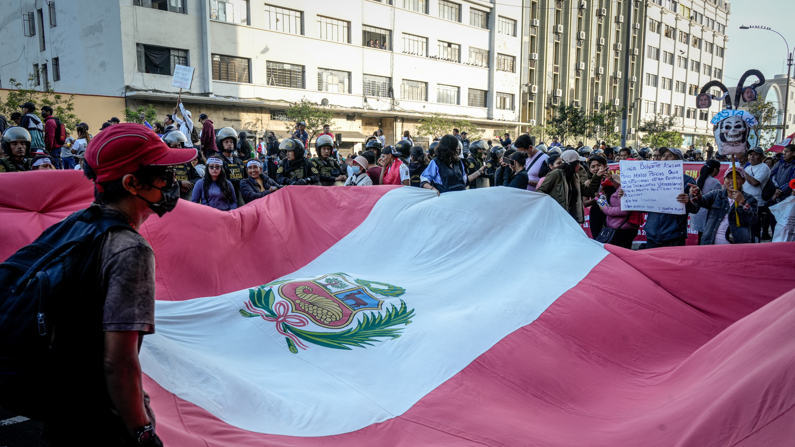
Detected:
[{"left": 536, "top": 149, "right": 605, "bottom": 224}]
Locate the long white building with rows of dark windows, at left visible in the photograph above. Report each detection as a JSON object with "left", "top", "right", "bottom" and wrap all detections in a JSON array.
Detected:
[{"left": 0, "top": 0, "right": 522, "bottom": 151}]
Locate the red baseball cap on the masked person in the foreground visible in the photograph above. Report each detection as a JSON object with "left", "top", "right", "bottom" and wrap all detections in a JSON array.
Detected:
[{"left": 85, "top": 123, "right": 198, "bottom": 183}]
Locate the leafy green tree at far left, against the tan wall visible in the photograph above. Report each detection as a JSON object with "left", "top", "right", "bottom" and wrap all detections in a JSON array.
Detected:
[{"left": 0, "top": 71, "right": 80, "bottom": 130}]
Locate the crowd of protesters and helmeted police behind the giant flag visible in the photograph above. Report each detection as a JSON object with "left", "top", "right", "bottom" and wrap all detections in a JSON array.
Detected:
[{"left": 0, "top": 101, "right": 795, "bottom": 248}]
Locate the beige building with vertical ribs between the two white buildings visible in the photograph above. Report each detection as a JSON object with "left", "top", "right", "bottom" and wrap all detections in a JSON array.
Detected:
[{"left": 521, "top": 0, "right": 646, "bottom": 144}]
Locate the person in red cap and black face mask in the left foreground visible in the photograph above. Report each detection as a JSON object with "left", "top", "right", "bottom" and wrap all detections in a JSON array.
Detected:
[{"left": 43, "top": 124, "right": 197, "bottom": 445}]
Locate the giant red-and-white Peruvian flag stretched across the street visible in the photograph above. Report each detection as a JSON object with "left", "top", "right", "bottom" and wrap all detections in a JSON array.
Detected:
[{"left": 0, "top": 172, "right": 795, "bottom": 447}]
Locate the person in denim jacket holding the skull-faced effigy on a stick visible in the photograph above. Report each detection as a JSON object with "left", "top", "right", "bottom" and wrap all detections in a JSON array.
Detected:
[{"left": 690, "top": 167, "right": 759, "bottom": 245}]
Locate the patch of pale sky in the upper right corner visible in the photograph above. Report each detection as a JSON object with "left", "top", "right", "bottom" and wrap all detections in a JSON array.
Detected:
[{"left": 723, "top": 0, "right": 795, "bottom": 83}]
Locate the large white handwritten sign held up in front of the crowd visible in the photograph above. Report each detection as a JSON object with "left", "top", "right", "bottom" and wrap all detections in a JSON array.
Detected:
[{"left": 619, "top": 160, "right": 685, "bottom": 214}]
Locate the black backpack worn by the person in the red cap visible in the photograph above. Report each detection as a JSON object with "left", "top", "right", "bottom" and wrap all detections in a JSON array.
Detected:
[{"left": 0, "top": 206, "right": 132, "bottom": 420}]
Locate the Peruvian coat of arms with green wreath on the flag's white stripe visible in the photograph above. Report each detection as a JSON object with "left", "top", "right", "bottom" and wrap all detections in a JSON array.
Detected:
[{"left": 240, "top": 273, "right": 414, "bottom": 354}]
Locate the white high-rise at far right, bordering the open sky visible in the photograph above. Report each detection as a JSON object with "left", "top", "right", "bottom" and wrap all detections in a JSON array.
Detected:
[{"left": 637, "top": 0, "right": 731, "bottom": 147}]
